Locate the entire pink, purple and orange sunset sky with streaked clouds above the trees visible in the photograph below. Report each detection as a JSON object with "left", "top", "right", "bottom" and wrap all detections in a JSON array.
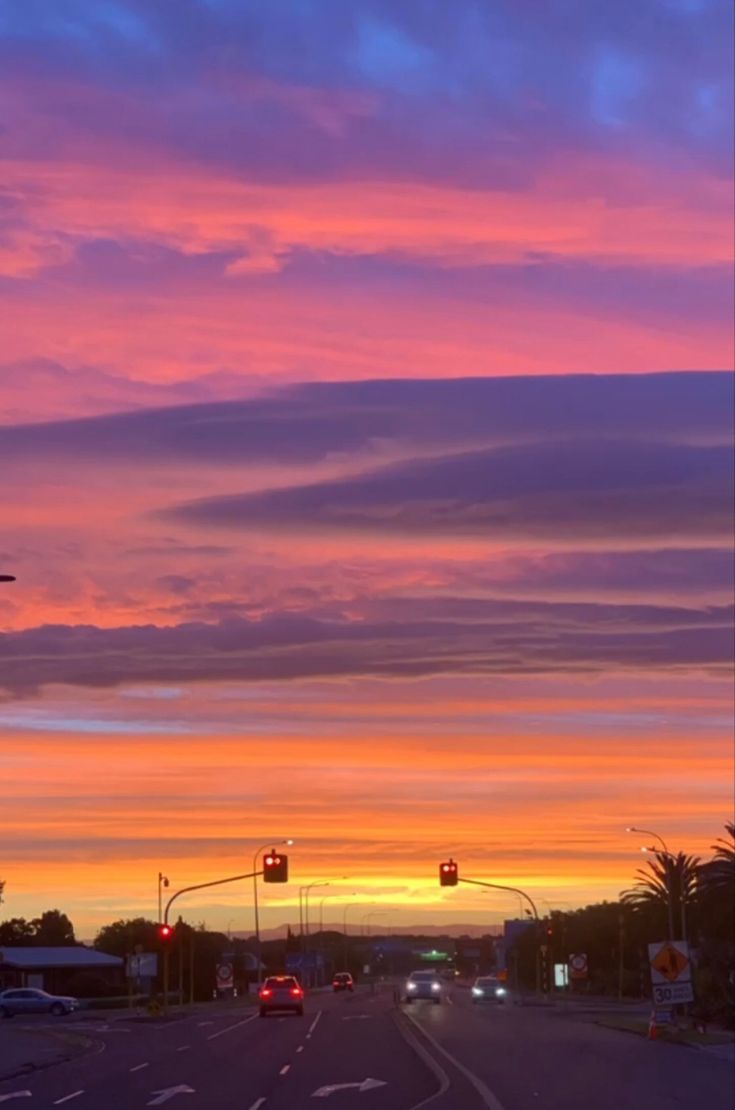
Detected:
[{"left": 0, "top": 0, "right": 733, "bottom": 937}]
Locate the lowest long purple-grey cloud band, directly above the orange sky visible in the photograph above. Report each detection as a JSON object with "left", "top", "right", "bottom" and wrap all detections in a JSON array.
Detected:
[{"left": 0, "top": 598, "right": 733, "bottom": 696}]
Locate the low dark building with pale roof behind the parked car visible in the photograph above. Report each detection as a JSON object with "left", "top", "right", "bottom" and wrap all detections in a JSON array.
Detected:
[{"left": 0, "top": 945, "right": 124, "bottom": 995}]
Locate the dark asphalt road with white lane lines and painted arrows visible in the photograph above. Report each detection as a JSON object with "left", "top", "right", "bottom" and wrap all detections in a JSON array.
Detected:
[{"left": 0, "top": 989, "right": 734, "bottom": 1110}]
